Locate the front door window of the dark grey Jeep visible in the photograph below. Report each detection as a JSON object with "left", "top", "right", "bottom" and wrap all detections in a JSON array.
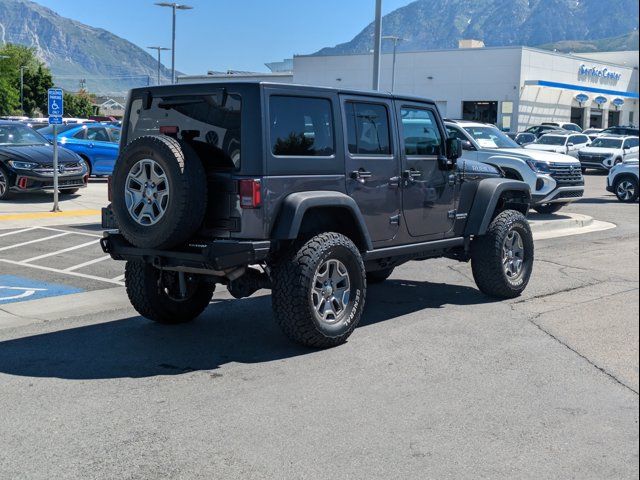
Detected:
[{"left": 400, "top": 107, "right": 442, "bottom": 155}]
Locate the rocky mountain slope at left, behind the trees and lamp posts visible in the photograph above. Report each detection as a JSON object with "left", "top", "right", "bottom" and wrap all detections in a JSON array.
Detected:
[{"left": 0, "top": 0, "right": 171, "bottom": 95}]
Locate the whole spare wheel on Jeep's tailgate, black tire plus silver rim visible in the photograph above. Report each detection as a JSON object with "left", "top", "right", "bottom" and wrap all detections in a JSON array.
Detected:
[{"left": 112, "top": 135, "right": 207, "bottom": 249}]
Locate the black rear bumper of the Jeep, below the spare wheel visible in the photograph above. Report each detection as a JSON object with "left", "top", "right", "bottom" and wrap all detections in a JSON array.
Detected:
[{"left": 100, "top": 231, "right": 271, "bottom": 276}]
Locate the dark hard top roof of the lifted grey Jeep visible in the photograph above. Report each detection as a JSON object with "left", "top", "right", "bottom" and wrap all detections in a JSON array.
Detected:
[{"left": 131, "top": 80, "right": 435, "bottom": 105}]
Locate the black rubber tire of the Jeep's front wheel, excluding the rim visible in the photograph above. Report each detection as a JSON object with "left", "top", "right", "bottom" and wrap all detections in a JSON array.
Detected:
[{"left": 471, "top": 210, "right": 534, "bottom": 298}]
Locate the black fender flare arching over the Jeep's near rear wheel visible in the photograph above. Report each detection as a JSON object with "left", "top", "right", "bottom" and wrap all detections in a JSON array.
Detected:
[{"left": 271, "top": 190, "right": 373, "bottom": 250}]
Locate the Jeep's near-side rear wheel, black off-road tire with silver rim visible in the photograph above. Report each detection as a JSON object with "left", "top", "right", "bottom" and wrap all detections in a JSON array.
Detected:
[{"left": 272, "top": 233, "right": 367, "bottom": 348}]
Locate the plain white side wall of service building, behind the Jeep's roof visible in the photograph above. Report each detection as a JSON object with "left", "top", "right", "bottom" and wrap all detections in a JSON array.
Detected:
[{"left": 293, "top": 48, "right": 521, "bottom": 122}]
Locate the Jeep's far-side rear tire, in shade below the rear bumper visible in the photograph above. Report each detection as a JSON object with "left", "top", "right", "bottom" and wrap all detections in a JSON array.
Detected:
[{"left": 124, "top": 261, "right": 215, "bottom": 325}]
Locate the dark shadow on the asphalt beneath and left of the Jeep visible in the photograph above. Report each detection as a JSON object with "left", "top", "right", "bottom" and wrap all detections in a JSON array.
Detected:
[{"left": 0, "top": 280, "right": 491, "bottom": 380}]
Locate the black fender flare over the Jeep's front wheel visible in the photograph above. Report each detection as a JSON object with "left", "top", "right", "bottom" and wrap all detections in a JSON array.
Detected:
[{"left": 460, "top": 178, "right": 531, "bottom": 236}]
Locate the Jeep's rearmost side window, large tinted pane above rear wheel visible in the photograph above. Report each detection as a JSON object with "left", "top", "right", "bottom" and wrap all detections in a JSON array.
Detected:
[{"left": 269, "top": 95, "right": 335, "bottom": 157}]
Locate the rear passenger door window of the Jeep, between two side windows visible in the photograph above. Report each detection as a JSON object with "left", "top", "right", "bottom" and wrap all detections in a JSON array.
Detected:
[{"left": 345, "top": 102, "right": 391, "bottom": 155}]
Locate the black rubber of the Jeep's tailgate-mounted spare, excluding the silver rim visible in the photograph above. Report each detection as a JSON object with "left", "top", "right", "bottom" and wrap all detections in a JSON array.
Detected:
[{"left": 112, "top": 135, "right": 207, "bottom": 249}]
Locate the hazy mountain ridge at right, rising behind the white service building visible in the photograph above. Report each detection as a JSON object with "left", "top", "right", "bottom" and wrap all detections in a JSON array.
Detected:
[{"left": 316, "top": 0, "right": 638, "bottom": 55}]
